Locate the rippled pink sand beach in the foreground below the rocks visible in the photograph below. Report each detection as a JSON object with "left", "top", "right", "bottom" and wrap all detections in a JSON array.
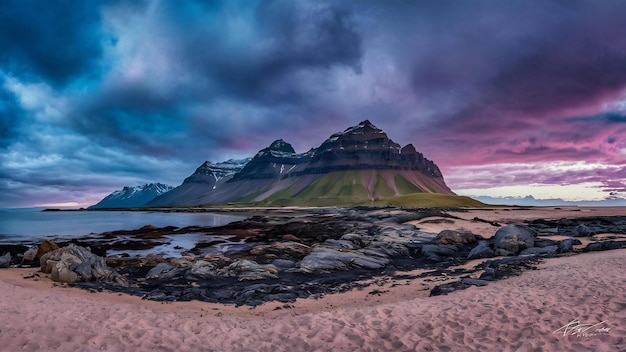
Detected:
[{"left": 0, "top": 250, "right": 626, "bottom": 351}]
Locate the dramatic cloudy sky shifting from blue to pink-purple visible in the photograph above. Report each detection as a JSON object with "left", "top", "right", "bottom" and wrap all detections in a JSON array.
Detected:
[{"left": 0, "top": 0, "right": 626, "bottom": 207}]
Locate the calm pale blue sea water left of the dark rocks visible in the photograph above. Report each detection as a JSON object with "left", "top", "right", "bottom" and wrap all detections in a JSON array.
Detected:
[{"left": 0, "top": 208, "right": 244, "bottom": 244}]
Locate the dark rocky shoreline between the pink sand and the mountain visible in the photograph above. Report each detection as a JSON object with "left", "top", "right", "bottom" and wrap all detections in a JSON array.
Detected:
[{"left": 0, "top": 207, "right": 626, "bottom": 306}]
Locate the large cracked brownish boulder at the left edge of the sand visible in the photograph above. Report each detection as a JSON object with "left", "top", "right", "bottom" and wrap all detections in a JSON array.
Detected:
[{"left": 40, "top": 244, "right": 127, "bottom": 285}]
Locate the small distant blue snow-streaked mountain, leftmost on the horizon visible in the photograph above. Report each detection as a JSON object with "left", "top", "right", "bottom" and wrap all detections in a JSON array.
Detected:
[{"left": 89, "top": 183, "right": 174, "bottom": 209}]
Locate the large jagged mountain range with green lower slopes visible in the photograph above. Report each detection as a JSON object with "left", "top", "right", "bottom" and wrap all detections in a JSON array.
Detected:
[{"left": 148, "top": 120, "right": 454, "bottom": 206}]
